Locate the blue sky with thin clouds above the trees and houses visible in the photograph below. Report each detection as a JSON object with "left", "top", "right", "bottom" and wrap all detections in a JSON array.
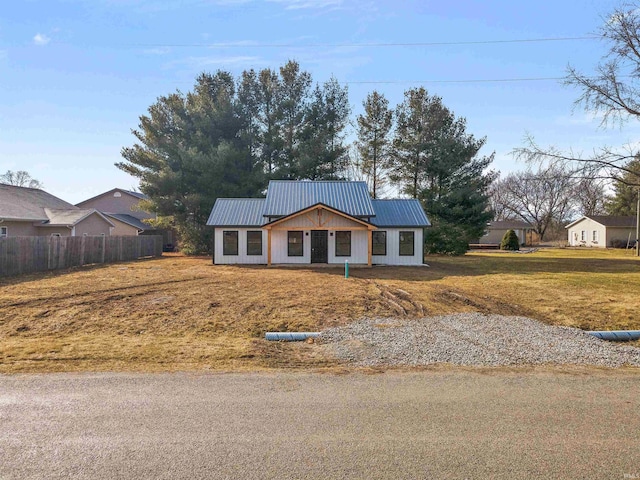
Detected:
[{"left": 0, "top": 0, "right": 640, "bottom": 202}]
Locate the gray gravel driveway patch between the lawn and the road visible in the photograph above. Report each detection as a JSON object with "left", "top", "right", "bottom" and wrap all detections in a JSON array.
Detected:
[{"left": 319, "top": 313, "right": 640, "bottom": 367}]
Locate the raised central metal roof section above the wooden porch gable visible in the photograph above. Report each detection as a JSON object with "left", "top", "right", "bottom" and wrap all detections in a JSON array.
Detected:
[{"left": 263, "top": 180, "right": 376, "bottom": 217}]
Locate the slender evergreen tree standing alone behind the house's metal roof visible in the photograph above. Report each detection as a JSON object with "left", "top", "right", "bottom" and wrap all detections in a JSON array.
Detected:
[{"left": 357, "top": 91, "right": 393, "bottom": 198}]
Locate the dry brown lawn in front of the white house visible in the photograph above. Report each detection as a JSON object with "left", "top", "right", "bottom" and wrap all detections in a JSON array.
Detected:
[{"left": 0, "top": 250, "right": 640, "bottom": 373}]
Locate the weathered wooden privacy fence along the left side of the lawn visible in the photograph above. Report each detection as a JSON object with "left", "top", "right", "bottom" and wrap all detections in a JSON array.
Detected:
[{"left": 0, "top": 235, "right": 162, "bottom": 276}]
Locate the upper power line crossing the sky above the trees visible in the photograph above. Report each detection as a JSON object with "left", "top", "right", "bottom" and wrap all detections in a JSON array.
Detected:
[{"left": 121, "top": 35, "right": 600, "bottom": 48}]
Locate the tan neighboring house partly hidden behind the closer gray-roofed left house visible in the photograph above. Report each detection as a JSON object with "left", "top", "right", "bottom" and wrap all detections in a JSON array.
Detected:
[{"left": 76, "top": 188, "right": 173, "bottom": 246}]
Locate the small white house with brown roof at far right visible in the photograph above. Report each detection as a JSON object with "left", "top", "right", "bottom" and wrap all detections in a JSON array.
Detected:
[{"left": 565, "top": 215, "right": 636, "bottom": 248}]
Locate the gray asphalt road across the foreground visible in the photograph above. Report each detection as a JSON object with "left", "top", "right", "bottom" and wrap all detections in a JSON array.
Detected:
[{"left": 0, "top": 370, "right": 640, "bottom": 480}]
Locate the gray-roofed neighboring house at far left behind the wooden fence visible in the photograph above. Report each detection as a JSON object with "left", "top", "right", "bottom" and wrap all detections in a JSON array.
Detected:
[{"left": 0, "top": 184, "right": 115, "bottom": 237}]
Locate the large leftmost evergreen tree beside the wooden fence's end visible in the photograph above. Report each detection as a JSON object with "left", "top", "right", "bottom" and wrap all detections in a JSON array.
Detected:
[{"left": 116, "top": 72, "right": 264, "bottom": 253}]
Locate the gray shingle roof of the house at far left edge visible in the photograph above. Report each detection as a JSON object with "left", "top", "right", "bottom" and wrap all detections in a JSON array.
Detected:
[{"left": 0, "top": 184, "right": 78, "bottom": 221}]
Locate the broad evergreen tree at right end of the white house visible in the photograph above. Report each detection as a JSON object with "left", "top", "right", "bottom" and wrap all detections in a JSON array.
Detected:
[{"left": 390, "top": 88, "right": 495, "bottom": 254}]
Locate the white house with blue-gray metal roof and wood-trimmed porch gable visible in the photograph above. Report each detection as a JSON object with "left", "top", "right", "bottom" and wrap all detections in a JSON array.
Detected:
[{"left": 207, "top": 180, "right": 430, "bottom": 265}]
